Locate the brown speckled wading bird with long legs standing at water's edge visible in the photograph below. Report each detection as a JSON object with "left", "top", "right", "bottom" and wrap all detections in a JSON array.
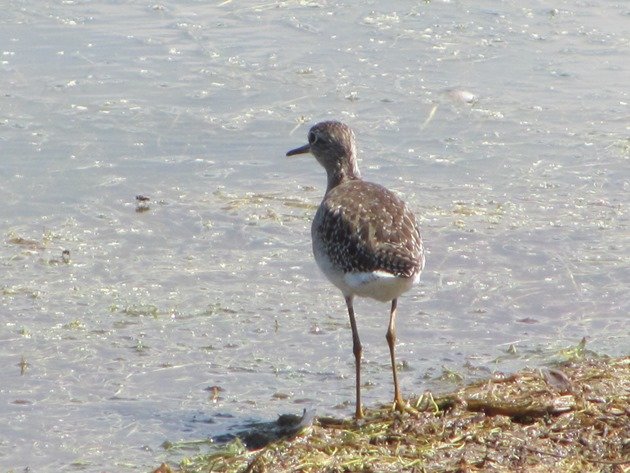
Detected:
[{"left": 286, "top": 121, "right": 425, "bottom": 419}]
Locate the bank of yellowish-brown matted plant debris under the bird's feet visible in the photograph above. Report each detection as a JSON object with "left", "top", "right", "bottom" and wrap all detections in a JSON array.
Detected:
[{"left": 155, "top": 357, "right": 630, "bottom": 473}]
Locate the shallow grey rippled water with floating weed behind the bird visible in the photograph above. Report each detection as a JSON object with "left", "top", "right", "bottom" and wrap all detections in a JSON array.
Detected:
[{"left": 0, "top": 0, "right": 630, "bottom": 472}]
